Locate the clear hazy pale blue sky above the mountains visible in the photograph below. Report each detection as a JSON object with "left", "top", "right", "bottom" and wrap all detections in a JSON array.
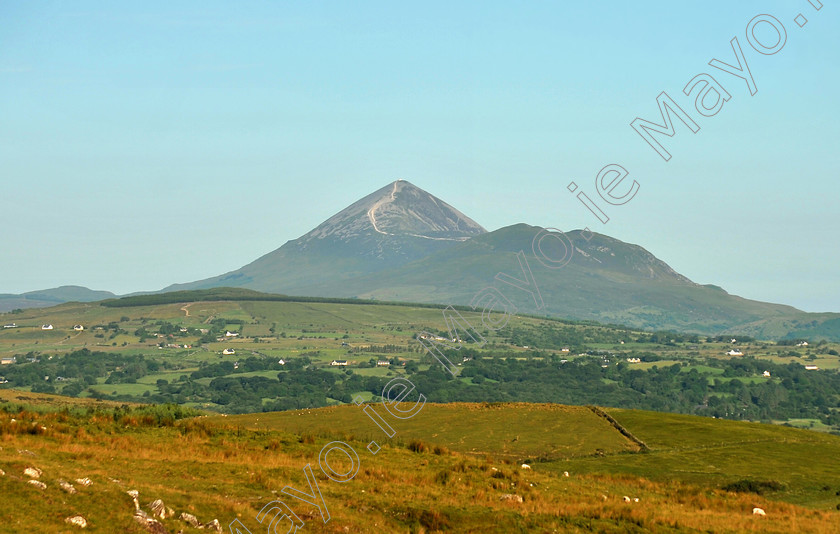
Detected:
[{"left": 0, "top": 0, "right": 840, "bottom": 311}]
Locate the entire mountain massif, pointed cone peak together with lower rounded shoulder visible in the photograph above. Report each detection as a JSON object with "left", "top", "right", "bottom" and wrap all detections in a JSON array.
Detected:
[{"left": 158, "top": 180, "right": 840, "bottom": 339}]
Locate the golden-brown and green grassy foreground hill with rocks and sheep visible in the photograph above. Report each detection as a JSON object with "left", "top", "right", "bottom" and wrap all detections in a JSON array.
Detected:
[{"left": 0, "top": 391, "right": 840, "bottom": 533}]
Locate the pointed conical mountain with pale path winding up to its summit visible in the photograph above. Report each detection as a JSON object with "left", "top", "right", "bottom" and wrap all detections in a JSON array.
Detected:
[{"left": 164, "top": 180, "right": 487, "bottom": 295}]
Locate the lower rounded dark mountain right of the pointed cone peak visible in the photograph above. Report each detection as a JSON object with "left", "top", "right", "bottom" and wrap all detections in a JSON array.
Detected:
[{"left": 280, "top": 224, "right": 804, "bottom": 333}]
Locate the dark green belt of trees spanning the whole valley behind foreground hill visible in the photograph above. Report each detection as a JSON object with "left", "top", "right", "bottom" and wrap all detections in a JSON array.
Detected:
[{"left": 4, "top": 347, "right": 840, "bottom": 428}]
